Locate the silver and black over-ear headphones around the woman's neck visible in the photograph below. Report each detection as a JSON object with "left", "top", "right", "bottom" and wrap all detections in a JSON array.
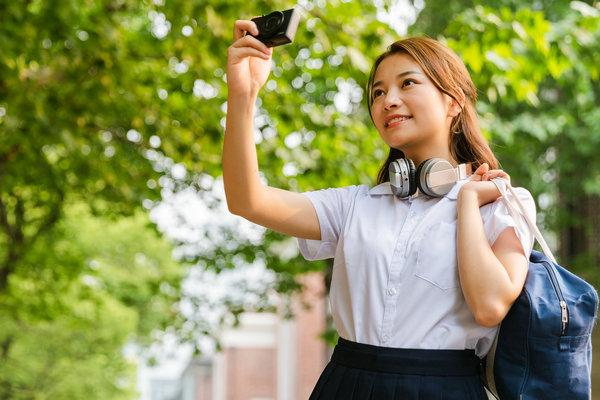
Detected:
[{"left": 389, "top": 158, "right": 471, "bottom": 198}]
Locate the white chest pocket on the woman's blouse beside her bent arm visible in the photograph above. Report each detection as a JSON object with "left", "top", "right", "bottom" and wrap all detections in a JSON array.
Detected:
[{"left": 415, "top": 222, "right": 460, "bottom": 290}]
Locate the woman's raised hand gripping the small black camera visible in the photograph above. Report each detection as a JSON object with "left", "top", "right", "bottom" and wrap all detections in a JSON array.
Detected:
[{"left": 227, "top": 20, "right": 273, "bottom": 95}]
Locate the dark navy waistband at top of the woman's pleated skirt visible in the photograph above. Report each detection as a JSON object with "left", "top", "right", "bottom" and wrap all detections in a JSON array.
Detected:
[{"left": 331, "top": 338, "right": 481, "bottom": 376}]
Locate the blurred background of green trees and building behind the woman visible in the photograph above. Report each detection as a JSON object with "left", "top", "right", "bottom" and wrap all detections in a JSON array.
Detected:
[{"left": 0, "top": 0, "right": 600, "bottom": 400}]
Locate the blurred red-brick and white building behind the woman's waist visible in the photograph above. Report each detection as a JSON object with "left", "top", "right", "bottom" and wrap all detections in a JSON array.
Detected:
[{"left": 178, "top": 274, "right": 330, "bottom": 400}]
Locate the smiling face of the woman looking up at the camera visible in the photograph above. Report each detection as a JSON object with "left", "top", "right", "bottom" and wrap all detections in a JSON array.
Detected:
[{"left": 369, "top": 53, "right": 460, "bottom": 162}]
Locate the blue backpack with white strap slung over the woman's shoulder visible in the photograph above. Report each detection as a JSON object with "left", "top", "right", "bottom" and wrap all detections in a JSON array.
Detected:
[{"left": 486, "top": 181, "right": 598, "bottom": 400}]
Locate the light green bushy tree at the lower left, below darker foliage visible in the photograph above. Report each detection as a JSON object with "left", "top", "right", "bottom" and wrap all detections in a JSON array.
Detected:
[{"left": 0, "top": 204, "right": 183, "bottom": 399}]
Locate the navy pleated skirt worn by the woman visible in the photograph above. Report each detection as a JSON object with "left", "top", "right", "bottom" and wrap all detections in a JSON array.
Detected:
[{"left": 310, "top": 338, "right": 487, "bottom": 400}]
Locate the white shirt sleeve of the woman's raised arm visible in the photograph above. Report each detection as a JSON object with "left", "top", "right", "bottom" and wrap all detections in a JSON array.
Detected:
[{"left": 298, "top": 186, "right": 358, "bottom": 260}]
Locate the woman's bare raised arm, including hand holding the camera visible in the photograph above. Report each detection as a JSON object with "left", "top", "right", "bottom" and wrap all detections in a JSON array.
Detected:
[{"left": 223, "top": 21, "right": 321, "bottom": 239}]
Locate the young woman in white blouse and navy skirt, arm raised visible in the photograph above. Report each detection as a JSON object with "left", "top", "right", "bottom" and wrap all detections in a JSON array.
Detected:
[{"left": 223, "top": 21, "right": 535, "bottom": 400}]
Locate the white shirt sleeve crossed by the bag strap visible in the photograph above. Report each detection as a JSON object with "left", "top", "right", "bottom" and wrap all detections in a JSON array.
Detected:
[{"left": 481, "top": 188, "right": 536, "bottom": 257}]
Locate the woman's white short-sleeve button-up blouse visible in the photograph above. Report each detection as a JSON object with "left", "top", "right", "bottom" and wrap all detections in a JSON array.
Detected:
[{"left": 299, "top": 180, "right": 535, "bottom": 357}]
